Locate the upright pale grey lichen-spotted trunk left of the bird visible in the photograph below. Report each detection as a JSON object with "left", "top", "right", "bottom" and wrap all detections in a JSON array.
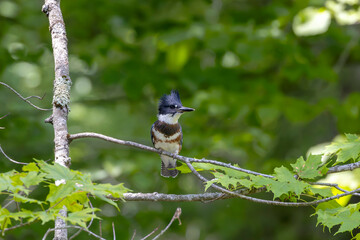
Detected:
[{"left": 42, "top": 0, "right": 71, "bottom": 240}]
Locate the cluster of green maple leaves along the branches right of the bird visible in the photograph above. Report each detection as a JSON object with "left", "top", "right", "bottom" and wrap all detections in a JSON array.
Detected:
[{"left": 178, "top": 134, "right": 360, "bottom": 234}]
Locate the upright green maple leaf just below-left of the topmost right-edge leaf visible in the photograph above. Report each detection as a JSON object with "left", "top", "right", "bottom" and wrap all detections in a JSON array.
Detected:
[{"left": 290, "top": 155, "right": 327, "bottom": 179}]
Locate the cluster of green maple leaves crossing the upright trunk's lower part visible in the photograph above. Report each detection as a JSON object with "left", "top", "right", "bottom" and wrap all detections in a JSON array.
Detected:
[{"left": 0, "top": 160, "right": 128, "bottom": 235}]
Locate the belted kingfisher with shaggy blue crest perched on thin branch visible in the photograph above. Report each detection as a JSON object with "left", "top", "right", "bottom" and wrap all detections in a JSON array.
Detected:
[{"left": 151, "top": 90, "right": 195, "bottom": 178}]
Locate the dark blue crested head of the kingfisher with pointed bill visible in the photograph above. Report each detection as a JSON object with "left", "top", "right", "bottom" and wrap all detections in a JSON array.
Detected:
[{"left": 158, "top": 90, "right": 195, "bottom": 124}]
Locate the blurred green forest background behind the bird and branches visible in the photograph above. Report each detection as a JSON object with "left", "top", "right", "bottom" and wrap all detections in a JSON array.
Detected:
[{"left": 0, "top": 0, "right": 360, "bottom": 240}]
